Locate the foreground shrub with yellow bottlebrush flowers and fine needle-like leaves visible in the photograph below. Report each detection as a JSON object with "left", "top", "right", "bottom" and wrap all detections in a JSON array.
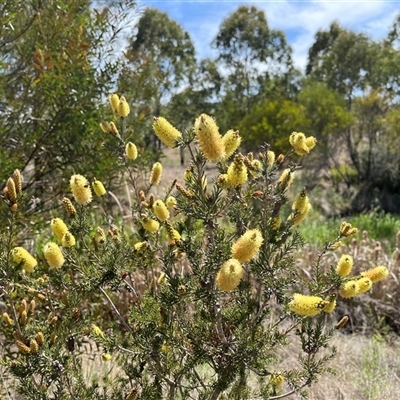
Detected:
[{"left": 0, "top": 104, "right": 388, "bottom": 400}]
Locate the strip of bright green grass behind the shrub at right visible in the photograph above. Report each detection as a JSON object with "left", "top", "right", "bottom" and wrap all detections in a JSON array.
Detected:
[{"left": 299, "top": 212, "right": 400, "bottom": 249}]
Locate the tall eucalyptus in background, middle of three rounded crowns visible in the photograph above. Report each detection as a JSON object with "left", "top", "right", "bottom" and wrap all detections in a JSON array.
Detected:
[{"left": 213, "top": 6, "right": 293, "bottom": 130}]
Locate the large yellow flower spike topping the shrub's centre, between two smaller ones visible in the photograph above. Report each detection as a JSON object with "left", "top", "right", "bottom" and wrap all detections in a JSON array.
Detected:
[{"left": 194, "top": 114, "right": 224, "bottom": 162}]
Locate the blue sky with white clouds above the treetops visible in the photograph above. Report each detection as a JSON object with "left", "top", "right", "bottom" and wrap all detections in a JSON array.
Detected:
[{"left": 139, "top": 0, "right": 400, "bottom": 70}]
